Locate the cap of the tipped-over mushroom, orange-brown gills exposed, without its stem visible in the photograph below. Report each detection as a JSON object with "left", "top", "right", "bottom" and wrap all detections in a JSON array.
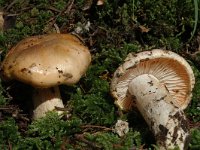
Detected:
[{"left": 111, "top": 49, "right": 195, "bottom": 111}]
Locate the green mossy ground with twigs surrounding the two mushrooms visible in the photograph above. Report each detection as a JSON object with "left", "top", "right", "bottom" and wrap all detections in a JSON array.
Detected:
[{"left": 0, "top": 0, "right": 200, "bottom": 150}]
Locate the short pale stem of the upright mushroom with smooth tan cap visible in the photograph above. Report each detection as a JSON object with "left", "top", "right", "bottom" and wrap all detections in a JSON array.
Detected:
[{"left": 33, "top": 86, "right": 64, "bottom": 119}]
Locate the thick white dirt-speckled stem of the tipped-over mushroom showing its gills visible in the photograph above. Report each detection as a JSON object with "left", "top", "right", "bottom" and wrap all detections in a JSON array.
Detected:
[{"left": 128, "top": 74, "right": 189, "bottom": 150}]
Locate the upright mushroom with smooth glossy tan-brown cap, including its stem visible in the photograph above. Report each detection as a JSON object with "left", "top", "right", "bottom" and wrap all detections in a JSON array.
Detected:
[{"left": 1, "top": 34, "right": 91, "bottom": 119}]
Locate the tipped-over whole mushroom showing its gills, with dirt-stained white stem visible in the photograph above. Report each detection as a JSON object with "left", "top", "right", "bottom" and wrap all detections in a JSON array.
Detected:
[{"left": 111, "top": 49, "right": 195, "bottom": 149}]
